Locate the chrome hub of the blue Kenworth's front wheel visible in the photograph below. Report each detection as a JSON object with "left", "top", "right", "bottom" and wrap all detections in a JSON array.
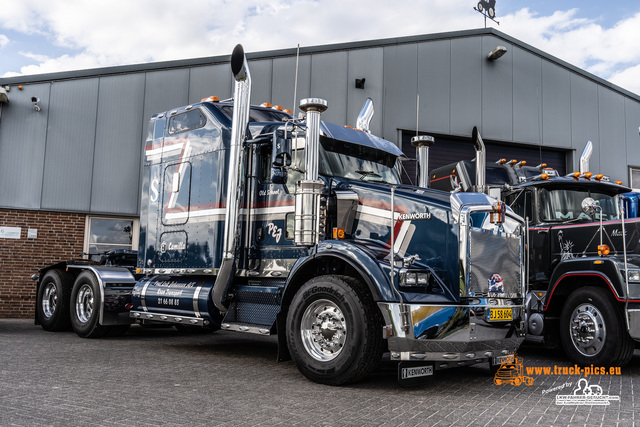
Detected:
[{"left": 300, "top": 299, "right": 347, "bottom": 362}]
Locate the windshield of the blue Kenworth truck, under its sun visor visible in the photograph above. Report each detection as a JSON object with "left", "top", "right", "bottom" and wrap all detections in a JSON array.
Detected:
[{"left": 320, "top": 139, "right": 401, "bottom": 185}]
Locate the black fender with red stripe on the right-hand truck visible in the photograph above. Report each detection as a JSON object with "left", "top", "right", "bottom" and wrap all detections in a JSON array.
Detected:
[{"left": 544, "top": 257, "right": 640, "bottom": 310}]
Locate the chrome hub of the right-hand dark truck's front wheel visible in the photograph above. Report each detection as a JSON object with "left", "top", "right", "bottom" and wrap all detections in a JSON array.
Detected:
[{"left": 569, "top": 304, "right": 607, "bottom": 356}]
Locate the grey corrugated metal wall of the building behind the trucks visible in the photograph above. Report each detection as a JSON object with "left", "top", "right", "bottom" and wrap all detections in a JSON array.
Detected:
[{"left": 0, "top": 29, "right": 640, "bottom": 215}]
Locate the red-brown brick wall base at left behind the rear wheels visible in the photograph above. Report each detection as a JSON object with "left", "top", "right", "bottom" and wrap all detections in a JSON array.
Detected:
[{"left": 0, "top": 209, "right": 85, "bottom": 318}]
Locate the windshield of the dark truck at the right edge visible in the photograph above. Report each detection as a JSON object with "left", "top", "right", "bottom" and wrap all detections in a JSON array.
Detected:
[{"left": 540, "top": 189, "right": 620, "bottom": 222}]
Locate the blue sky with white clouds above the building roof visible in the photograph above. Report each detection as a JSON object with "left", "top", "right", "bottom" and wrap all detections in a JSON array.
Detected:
[{"left": 0, "top": 0, "right": 640, "bottom": 94}]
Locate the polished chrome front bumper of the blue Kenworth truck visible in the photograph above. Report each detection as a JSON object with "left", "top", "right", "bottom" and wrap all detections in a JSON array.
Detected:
[{"left": 378, "top": 300, "right": 525, "bottom": 367}]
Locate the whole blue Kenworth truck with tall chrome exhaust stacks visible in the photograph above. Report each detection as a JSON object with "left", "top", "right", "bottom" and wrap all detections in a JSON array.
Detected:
[{"left": 34, "top": 45, "right": 525, "bottom": 385}]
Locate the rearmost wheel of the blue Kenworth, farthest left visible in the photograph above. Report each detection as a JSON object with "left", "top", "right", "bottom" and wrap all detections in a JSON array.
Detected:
[{"left": 36, "top": 270, "right": 73, "bottom": 332}]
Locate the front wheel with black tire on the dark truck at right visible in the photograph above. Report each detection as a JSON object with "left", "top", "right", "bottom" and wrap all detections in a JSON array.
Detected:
[{"left": 560, "top": 287, "right": 634, "bottom": 366}]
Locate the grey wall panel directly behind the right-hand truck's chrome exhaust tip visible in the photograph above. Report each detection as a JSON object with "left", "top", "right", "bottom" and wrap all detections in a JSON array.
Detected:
[{"left": 569, "top": 74, "right": 606, "bottom": 173}]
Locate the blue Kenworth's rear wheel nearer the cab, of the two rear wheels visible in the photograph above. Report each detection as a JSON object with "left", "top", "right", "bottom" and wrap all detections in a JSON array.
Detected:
[{"left": 71, "top": 271, "right": 111, "bottom": 338}]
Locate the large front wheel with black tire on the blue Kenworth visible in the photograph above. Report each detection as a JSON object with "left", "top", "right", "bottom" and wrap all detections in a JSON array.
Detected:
[{"left": 286, "top": 276, "right": 384, "bottom": 385}]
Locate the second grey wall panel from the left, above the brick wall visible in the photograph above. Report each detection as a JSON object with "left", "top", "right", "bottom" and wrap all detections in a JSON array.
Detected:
[{"left": 41, "top": 78, "right": 99, "bottom": 212}]
